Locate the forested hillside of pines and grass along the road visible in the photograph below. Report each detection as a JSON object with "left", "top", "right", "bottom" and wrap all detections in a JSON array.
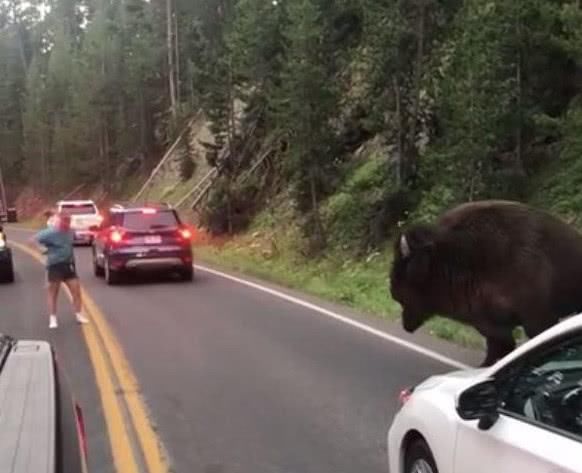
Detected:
[{"left": 0, "top": 0, "right": 582, "bottom": 346}]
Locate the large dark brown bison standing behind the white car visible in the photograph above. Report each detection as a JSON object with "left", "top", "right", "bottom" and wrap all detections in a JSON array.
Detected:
[{"left": 390, "top": 200, "right": 582, "bottom": 366}]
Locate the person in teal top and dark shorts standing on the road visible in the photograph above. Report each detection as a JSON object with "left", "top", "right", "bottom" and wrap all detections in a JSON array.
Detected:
[{"left": 33, "top": 214, "right": 89, "bottom": 329}]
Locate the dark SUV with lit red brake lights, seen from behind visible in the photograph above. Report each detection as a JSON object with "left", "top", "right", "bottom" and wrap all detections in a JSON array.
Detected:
[{"left": 92, "top": 205, "right": 194, "bottom": 285}]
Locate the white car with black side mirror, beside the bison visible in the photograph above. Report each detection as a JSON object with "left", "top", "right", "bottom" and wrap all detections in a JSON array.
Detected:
[{"left": 388, "top": 314, "right": 582, "bottom": 473}]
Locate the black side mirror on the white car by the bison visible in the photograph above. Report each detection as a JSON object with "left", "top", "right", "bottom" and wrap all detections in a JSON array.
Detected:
[{"left": 457, "top": 379, "right": 499, "bottom": 430}]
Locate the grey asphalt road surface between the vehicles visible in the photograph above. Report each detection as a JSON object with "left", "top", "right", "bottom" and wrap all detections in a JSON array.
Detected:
[{"left": 0, "top": 227, "right": 479, "bottom": 473}]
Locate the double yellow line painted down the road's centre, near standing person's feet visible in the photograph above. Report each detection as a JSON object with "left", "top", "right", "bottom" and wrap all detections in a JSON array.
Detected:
[{"left": 11, "top": 241, "right": 170, "bottom": 473}]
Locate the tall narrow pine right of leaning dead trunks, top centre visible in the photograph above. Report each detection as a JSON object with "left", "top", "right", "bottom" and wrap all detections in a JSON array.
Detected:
[{"left": 275, "top": 0, "right": 337, "bottom": 249}]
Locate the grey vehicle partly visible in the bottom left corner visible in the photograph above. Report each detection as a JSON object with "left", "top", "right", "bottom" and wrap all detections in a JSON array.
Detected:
[{"left": 0, "top": 335, "right": 88, "bottom": 473}]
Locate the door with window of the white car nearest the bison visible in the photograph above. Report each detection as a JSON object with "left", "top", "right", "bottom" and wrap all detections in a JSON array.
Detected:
[{"left": 454, "top": 333, "right": 582, "bottom": 473}]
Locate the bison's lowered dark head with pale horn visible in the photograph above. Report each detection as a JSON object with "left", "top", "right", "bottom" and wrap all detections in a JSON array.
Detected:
[{"left": 390, "top": 225, "right": 437, "bottom": 332}]
